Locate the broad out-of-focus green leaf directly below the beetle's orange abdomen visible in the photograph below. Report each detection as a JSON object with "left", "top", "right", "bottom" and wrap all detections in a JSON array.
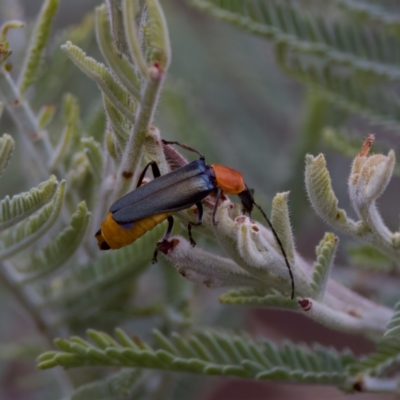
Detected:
[{"left": 38, "top": 225, "right": 165, "bottom": 324}]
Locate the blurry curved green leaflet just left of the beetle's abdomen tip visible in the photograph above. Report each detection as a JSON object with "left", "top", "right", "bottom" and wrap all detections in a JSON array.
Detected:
[{"left": 16, "top": 202, "right": 91, "bottom": 278}]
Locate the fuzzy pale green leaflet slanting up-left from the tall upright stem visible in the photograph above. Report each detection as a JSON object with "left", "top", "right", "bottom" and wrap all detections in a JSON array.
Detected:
[{"left": 61, "top": 42, "right": 136, "bottom": 122}]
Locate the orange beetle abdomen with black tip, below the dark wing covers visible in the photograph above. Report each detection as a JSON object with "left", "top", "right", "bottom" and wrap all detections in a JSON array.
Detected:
[{"left": 96, "top": 212, "right": 170, "bottom": 250}]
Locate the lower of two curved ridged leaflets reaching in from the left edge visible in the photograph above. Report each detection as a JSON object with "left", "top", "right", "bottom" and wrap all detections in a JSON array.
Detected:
[{"left": 0, "top": 181, "right": 65, "bottom": 261}]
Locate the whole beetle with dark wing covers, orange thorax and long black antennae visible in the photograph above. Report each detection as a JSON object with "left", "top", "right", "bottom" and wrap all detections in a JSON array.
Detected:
[{"left": 95, "top": 140, "right": 294, "bottom": 299}]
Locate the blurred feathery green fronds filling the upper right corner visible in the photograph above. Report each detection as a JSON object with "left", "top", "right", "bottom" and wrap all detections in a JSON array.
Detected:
[{"left": 188, "top": 0, "right": 400, "bottom": 145}]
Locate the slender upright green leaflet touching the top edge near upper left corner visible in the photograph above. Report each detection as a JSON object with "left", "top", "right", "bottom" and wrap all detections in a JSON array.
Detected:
[{"left": 18, "top": 0, "right": 59, "bottom": 94}]
